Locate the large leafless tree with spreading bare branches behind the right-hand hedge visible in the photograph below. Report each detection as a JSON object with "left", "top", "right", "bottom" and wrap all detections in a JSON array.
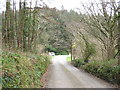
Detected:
[{"left": 77, "top": 1, "right": 118, "bottom": 59}]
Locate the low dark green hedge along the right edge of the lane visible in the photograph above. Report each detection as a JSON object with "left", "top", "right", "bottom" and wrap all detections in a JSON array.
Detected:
[{"left": 71, "top": 59, "right": 120, "bottom": 85}]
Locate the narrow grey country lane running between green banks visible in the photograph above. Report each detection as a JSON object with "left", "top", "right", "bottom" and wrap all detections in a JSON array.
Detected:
[{"left": 47, "top": 55, "right": 113, "bottom": 88}]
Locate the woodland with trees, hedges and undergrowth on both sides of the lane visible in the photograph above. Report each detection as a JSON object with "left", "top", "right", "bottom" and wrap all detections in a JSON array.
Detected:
[{"left": 0, "top": 0, "right": 120, "bottom": 88}]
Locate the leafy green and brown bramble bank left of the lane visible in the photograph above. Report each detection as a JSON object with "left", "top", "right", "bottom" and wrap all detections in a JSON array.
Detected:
[{"left": 1, "top": 52, "right": 50, "bottom": 88}]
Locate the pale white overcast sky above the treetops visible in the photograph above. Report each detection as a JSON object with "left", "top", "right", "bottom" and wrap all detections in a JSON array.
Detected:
[{"left": 0, "top": 0, "right": 119, "bottom": 12}]
